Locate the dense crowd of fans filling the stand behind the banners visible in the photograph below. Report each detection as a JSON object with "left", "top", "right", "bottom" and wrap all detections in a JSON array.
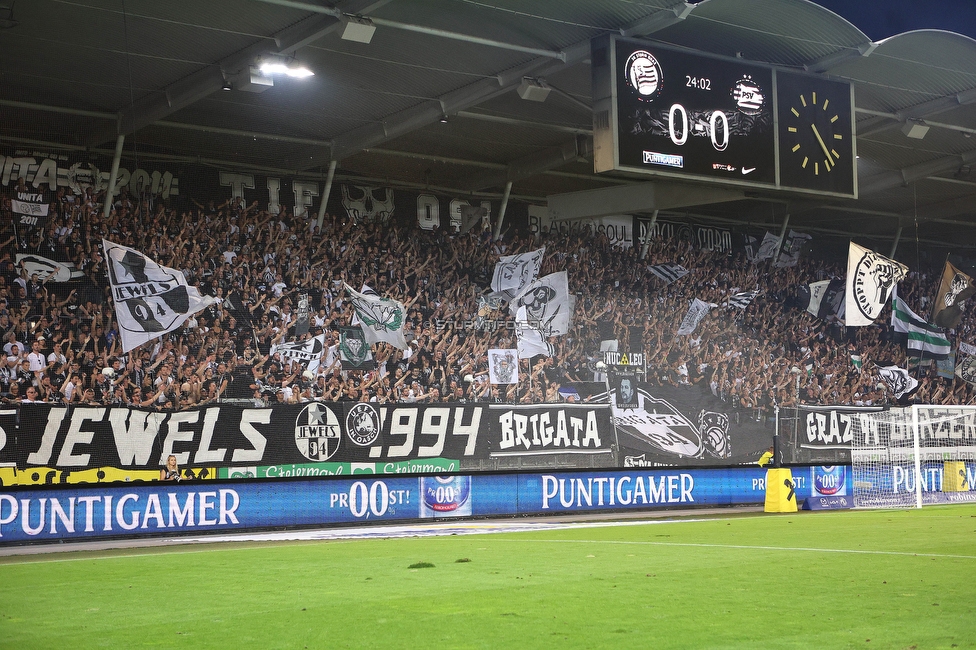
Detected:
[{"left": 0, "top": 177, "right": 976, "bottom": 409}]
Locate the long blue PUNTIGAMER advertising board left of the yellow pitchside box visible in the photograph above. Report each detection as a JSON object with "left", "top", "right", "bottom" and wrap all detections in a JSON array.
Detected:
[{"left": 0, "top": 467, "right": 765, "bottom": 544}]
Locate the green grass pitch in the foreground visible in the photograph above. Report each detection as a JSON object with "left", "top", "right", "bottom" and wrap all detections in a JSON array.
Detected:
[{"left": 0, "top": 505, "right": 976, "bottom": 650}]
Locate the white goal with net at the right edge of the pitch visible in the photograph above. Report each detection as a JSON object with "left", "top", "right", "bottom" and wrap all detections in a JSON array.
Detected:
[{"left": 851, "top": 406, "right": 976, "bottom": 508}]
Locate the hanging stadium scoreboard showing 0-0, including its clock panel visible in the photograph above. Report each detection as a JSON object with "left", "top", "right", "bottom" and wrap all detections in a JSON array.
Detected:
[{"left": 592, "top": 36, "right": 857, "bottom": 198}]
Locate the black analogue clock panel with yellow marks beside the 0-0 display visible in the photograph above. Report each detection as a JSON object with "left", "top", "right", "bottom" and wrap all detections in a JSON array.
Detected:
[{"left": 776, "top": 72, "right": 856, "bottom": 196}]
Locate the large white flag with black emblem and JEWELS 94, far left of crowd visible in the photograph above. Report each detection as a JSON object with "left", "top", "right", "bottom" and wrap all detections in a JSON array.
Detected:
[{"left": 102, "top": 239, "right": 214, "bottom": 353}]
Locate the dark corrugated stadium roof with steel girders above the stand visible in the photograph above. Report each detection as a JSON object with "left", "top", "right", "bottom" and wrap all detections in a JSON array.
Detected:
[{"left": 0, "top": 0, "right": 976, "bottom": 250}]
